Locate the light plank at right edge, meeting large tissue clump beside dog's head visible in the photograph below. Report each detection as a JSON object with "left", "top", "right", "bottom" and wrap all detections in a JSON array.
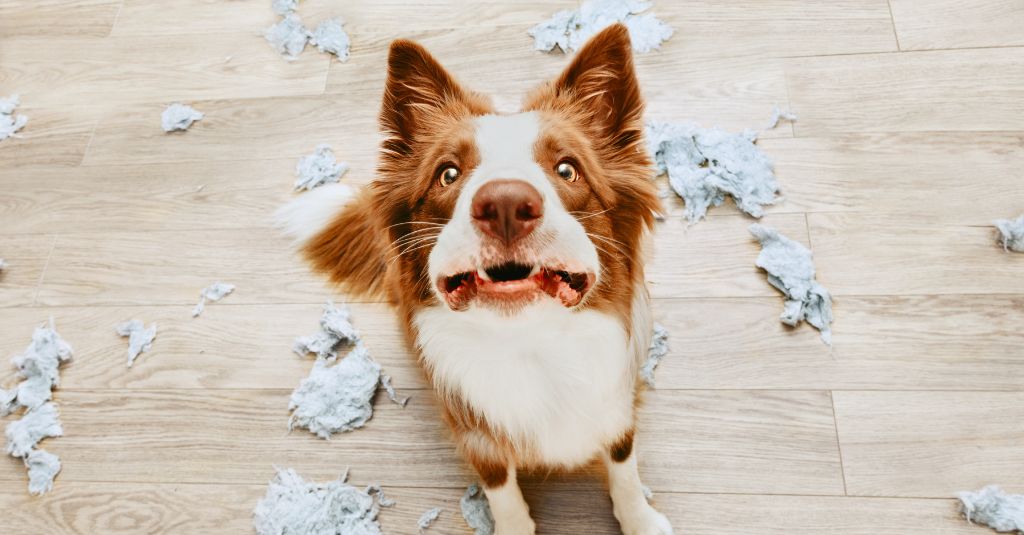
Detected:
[{"left": 758, "top": 131, "right": 1024, "bottom": 218}]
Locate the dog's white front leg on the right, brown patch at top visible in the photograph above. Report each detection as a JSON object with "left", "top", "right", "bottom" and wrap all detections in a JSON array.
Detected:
[{"left": 604, "top": 430, "right": 672, "bottom": 535}]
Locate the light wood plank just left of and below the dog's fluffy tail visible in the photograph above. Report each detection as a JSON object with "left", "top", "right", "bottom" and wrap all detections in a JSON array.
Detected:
[{"left": 38, "top": 228, "right": 331, "bottom": 305}]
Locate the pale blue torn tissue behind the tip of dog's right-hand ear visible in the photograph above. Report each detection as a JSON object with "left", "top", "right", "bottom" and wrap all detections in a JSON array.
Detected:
[{"left": 527, "top": 0, "right": 672, "bottom": 53}]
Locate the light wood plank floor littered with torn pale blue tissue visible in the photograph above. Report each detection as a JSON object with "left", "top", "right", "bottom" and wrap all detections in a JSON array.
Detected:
[{"left": 0, "top": 0, "right": 1024, "bottom": 535}]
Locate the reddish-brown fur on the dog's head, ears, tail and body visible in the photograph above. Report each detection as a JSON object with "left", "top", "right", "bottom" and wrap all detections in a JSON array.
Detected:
[{"left": 305, "top": 25, "right": 660, "bottom": 477}]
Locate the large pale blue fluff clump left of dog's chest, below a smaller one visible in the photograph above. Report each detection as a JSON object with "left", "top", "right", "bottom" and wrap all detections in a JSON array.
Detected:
[{"left": 288, "top": 343, "right": 381, "bottom": 439}]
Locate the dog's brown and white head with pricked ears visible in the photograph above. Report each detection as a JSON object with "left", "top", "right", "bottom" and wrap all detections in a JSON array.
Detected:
[{"left": 292, "top": 25, "right": 659, "bottom": 313}]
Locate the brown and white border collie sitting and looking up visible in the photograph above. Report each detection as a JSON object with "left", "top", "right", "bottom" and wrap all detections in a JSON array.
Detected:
[{"left": 279, "top": 25, "right": 672, "bottom": 535}]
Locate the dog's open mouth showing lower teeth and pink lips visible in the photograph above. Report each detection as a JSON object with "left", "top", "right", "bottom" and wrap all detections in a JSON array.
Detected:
[{"left": 437, "top": 261, "right": 594, "bottom": 311}]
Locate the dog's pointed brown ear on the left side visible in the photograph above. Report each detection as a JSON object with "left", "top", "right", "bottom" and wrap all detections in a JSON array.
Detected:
[{"left": 380, "top": 39, "right": 487, "bottom": 151}]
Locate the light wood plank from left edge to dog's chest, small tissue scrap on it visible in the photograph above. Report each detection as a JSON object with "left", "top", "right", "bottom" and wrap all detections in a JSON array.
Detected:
[{"left": 0, "top": 296, "right": 429, "bottom": 392}]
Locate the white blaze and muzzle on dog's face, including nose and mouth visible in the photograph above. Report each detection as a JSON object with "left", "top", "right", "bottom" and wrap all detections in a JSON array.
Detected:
[{"left": 428, "top": 112, "right": 601, "bottom": 311}]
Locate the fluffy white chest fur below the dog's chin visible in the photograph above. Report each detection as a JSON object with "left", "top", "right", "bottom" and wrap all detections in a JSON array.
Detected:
[{"left": 415, "top": 299, "right": 634, "bottom": 466}]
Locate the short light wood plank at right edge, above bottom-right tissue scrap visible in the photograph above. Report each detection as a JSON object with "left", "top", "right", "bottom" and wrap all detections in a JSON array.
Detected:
[{"left": 834, "top": 392, "right": 1024, "bottom": 498}]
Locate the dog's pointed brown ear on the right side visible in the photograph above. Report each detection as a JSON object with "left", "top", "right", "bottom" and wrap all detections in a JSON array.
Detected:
[{"left": 553, "top": 24, "right": 643, "bottom": 150}]
